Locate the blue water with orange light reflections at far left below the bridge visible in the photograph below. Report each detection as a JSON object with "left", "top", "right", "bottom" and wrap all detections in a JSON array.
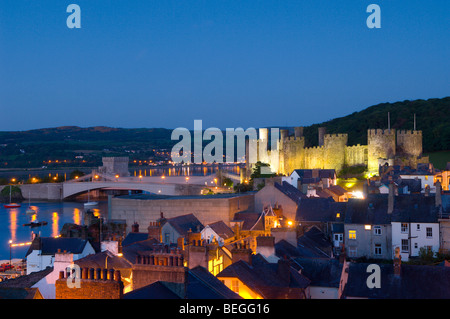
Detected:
[{"left": 0, "top": 201, "right": 108, "bottom": 261}]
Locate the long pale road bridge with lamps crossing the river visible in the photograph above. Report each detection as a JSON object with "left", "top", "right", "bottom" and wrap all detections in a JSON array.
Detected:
[{"left": 61, "top": 173, "right": 240, "bottom": 199}]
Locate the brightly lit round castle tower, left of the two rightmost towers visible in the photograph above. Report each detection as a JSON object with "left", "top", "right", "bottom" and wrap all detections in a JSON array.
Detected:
[{"left": 367, "top": 129, "right": 396, "bottom": 173}]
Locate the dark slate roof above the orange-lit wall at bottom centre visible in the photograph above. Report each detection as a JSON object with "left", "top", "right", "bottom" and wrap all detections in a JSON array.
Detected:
[{"left": 217, "top": 254, "right": 310, "bottom": 299}]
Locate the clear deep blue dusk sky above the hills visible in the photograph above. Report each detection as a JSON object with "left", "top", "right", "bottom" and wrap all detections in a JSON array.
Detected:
[{"left": 0, "top": 0, "right": 450, "bottom": 131}]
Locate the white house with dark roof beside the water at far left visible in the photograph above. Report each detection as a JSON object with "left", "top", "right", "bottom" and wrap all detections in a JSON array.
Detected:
[{"left": 25, "top": 237, "right": 95, "bottom": 274}]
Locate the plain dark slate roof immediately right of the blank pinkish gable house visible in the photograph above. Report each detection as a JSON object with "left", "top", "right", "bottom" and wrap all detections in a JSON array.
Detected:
[{"left": 295, "top": 197, "right": 347, "bottom": 222}]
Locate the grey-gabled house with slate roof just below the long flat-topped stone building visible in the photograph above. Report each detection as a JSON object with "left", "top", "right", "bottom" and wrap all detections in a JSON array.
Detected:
[{"left": 161, "top": 214, "right": 204, "bottom": 245}]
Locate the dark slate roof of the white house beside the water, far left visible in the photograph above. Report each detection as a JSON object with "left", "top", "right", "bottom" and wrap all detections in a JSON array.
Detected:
[{"left": 25, "top": 237, "right": 88, "bottom": 256}]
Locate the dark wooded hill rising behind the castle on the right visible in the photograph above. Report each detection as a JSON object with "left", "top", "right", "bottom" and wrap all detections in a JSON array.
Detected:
[{"left": 303, "top": 97, "right": 450, "bottom": 153}]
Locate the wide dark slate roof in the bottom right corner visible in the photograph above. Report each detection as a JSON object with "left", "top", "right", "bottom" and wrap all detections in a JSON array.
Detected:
[{"left": 344, "top": 263, "right": 450, "bottom": 299}]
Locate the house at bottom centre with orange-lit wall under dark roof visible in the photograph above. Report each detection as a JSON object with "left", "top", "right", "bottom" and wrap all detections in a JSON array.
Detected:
[{"left": 217, "top": 254, "right": 310, "bottom": 299}]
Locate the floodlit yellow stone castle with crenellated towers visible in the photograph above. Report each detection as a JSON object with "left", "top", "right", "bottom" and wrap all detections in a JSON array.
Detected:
[{"left": 246, "top": 127, "right": 429, "bottom": 175}]
